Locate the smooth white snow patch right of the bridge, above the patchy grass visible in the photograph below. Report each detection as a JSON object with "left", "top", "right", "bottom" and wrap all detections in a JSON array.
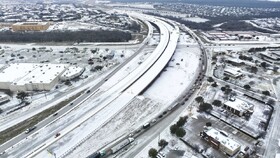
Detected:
[{"left": 143, "top": 33, "right": 201, "bottom": 105}]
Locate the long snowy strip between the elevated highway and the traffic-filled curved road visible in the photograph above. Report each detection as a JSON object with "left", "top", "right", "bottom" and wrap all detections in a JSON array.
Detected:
[{"left": 65, "top": 31, "right": 200, "bottom": 158}]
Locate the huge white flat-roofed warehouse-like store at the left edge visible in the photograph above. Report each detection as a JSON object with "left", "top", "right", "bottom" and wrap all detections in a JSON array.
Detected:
[{"left": 0, "top": 63, "right": 68, "bottom": 91}]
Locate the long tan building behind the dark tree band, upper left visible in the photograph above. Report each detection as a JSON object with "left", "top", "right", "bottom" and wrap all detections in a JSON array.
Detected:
[{"left": 12, "top": 22, "right": 50, "bottom": 31}]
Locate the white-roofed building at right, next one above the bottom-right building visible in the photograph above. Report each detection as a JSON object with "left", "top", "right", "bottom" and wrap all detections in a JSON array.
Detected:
[{"left": 224, "top": 98, "right": 254, "bottom": 117}]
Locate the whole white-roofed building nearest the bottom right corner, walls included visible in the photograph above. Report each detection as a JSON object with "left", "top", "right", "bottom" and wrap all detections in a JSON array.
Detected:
[{"left": 200, "top": 127, "right": 241, "bottom": 156}]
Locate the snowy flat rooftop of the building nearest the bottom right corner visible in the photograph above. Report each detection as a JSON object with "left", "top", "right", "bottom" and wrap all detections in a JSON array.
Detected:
[{"left": 205, "top": 128, "right": 240, "bottom": 151}]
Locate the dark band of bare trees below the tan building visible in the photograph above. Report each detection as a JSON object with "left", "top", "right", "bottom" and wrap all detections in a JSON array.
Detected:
[{"left": 0, "top": 30, "right": 132, "bottom": 42}]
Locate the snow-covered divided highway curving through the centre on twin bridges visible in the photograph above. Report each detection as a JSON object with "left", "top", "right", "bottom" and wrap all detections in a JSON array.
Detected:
[{"left": 0, "top": 17, "right": 179, "bottom": 157}]
